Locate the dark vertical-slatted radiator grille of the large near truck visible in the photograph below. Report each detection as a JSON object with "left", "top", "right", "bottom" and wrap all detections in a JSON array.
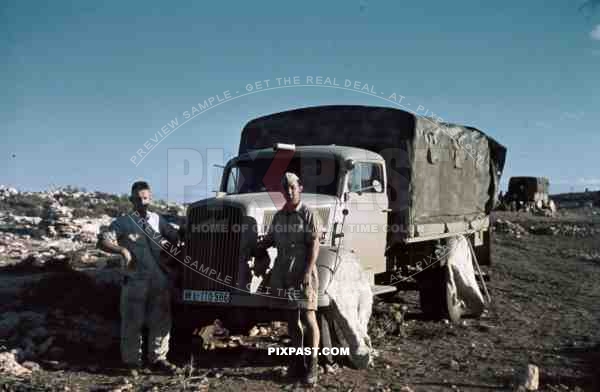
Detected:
[{"left": 183, "top": 206, "right": 242, "bottom": 290}]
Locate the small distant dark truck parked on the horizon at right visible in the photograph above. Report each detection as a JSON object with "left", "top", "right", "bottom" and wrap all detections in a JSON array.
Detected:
[{"left": 504, "top": 177, "right": 550, "bottom": 211}]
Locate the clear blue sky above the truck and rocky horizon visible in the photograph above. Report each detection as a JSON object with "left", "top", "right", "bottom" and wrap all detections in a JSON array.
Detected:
[{"left": 0, "top": 0, "right": 600, "bottom": 202}]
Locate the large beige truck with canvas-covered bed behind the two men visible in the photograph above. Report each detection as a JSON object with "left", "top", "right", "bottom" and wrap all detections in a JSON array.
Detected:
[{"left": 172, "top": 106, "right": 506, "bottom": 331}]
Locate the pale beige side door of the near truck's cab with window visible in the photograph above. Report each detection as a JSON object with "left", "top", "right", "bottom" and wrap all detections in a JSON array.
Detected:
[{"left": 343, "top": 161, "right": 388, "bottom": 274}]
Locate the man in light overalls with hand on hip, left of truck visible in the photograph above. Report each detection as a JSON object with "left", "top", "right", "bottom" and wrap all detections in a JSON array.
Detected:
[{"left": 98, "top": 181, "right": 177, "bottom": 373}]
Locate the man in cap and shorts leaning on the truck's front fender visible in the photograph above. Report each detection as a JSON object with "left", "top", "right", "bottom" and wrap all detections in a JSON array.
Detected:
[{"left": 258, "top": 172, "right": 320, "bottom": 385}]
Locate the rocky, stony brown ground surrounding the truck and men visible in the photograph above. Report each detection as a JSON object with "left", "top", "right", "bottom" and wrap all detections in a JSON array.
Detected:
[{"left": 0, "top": 189, "right": 600, "bottom": 391}]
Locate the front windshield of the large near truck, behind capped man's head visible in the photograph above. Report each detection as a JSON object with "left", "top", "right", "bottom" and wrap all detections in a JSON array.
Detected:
[{"left": 225, "top": 156, "right": 339, "bottom": 195}]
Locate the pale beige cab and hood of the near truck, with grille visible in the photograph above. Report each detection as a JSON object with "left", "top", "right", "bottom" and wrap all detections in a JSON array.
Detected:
[{"left": 181, "top": 144, "right": 388, "bottom": 308}]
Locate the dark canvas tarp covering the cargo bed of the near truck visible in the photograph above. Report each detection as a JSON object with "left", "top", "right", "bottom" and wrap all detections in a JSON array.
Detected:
[{"left": 239, "top": 106, "right": 506, "bottom": 236}]
